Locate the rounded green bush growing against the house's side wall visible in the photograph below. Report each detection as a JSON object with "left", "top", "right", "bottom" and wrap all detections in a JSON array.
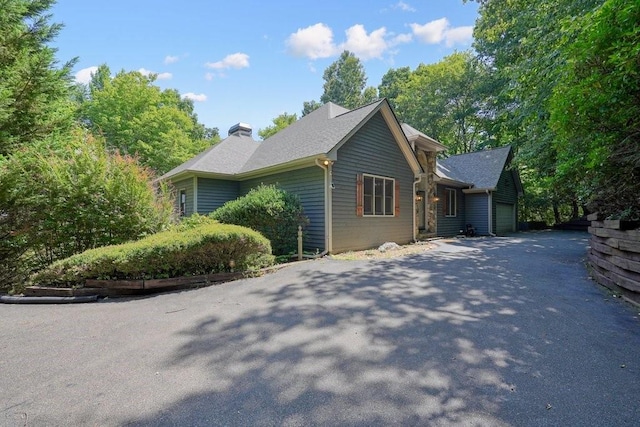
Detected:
[{"left": 211, "top": 185, "right": 309, "bottom": 255}]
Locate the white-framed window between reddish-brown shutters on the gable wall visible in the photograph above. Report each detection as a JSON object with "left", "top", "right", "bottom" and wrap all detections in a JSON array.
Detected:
[{"left": 356, "top": 174, "right": 399, "bottom": 216}]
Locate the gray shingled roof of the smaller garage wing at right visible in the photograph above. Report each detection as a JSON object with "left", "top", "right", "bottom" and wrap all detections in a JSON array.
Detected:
[{"left": 437, "top": 145, "right": 511, "bottom": 190}]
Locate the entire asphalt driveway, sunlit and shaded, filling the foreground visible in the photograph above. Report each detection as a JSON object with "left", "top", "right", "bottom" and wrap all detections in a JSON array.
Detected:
[{"left": 0, "top": 232, "right": 640, "bottom": 426}]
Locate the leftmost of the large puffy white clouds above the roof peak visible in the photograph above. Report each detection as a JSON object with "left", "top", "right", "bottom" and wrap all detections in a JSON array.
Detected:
[{"left": 286, "top": 23, "right": 337, "bottom": 59}]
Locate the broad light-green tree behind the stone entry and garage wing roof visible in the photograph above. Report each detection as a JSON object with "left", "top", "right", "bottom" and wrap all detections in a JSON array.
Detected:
[{"left": 392, "top": 52, "right": 491, "bottom": 154}]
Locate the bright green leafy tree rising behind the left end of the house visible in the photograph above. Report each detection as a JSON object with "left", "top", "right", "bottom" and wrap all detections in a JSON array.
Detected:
[{"left": 79, "top": 65, "right": 219, "bottom": 174}]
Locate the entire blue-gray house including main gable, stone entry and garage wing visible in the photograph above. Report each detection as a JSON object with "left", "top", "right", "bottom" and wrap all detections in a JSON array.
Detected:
[{"left": 160, "top": 99, "right": 522, "bottom": 253}]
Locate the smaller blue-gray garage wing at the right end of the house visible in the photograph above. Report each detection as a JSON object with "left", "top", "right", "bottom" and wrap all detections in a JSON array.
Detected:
[{"left": 436, "top": 146, "right": 523, "bottom": 236}]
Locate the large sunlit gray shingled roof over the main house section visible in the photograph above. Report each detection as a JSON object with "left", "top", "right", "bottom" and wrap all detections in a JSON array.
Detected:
[{"left": 160, "top": 100, "right": 386, "bottom": 179}]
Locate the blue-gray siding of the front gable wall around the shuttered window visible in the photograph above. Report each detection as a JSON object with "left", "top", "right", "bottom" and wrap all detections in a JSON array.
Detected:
[{"left": 332, "top": 113, "right": 414, "bottom": 253}]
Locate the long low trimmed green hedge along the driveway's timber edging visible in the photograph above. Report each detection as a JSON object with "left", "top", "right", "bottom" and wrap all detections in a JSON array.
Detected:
[{"left": 32, "top": 224, "right": 273, "bottom": 287}]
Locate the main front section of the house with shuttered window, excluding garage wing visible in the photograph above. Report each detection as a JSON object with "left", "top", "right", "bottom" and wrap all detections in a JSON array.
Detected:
[{"left": 161, "top": 99, "right": 430, "bottom": 253}]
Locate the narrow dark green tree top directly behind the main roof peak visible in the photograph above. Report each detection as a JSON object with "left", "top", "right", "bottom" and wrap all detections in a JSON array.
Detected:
[{"left": 320, "top": 50, "right": 378, "bottom": 109}]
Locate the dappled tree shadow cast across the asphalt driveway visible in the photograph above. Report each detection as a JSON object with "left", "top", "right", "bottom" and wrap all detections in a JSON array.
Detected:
[{"left": 123, "top": 232, "right": 640, "bottom": 426}]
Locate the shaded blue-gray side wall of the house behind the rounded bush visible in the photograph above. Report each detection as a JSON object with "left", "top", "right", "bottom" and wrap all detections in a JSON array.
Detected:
[{"left": 238, "top": 166, "right": 325, "bottom": 252}]
